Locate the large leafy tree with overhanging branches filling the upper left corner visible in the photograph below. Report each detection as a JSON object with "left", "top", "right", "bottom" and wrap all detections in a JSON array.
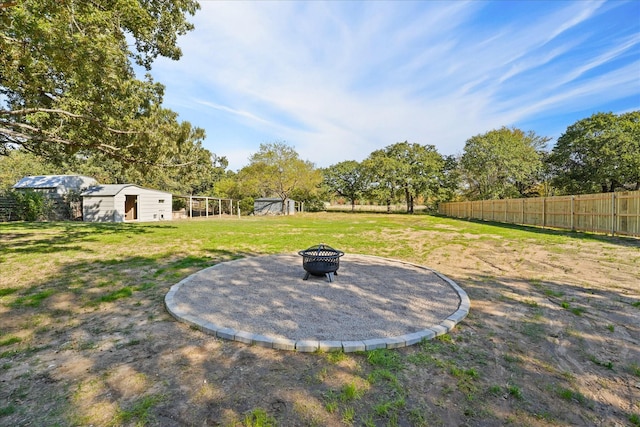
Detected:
[{"left": 0, "top": 0, "right": 198, "bottom": 169}]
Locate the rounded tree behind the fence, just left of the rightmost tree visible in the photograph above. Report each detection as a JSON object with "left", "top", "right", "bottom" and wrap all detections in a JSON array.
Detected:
[{"left": 460, "top": 127, "right": 549, "bottom": 200}]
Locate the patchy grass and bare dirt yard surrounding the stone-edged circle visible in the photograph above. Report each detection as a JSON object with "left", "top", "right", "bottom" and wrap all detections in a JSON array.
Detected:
[{"left": 0, "top": 214, "right": 640, "bottom": 426}]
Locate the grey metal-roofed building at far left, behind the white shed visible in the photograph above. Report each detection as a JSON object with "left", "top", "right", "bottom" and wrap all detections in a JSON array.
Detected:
[{"left": 13, "top": 175, "right": 98, "bottom": 220}]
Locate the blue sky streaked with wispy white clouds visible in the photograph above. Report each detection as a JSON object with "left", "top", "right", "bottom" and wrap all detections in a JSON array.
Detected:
[{"left": 146, "top": 0, "right": 640, "bottom": 170}]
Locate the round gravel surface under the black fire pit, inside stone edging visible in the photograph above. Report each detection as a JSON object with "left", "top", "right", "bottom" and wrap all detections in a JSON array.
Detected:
[{"left": 169, "top": 254, "right": 460, "bottom": 341}]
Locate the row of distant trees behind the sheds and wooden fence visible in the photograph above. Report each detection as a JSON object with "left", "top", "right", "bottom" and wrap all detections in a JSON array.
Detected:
[{"left": 0, "top": 111, "right": 640, "bottom": 217}]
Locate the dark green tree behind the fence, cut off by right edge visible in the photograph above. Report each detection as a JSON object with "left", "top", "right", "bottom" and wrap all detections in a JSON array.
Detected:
[{"left": 548, "top": 111, "right": 640, "bottom": 194}]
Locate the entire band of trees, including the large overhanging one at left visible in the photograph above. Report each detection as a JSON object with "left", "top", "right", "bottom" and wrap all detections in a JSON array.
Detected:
[{"left": 0, "top": 0, "right": 640, "bottom": 216}]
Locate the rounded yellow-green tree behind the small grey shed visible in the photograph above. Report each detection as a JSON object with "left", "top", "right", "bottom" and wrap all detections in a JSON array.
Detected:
[{"left": 237, "top": 142, "right": 322, "bottom": 213}]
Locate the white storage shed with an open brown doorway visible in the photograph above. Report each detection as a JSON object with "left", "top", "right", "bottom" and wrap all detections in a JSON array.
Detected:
[{"left": 82, "top": 184, "right": 172, "bottom": 222}]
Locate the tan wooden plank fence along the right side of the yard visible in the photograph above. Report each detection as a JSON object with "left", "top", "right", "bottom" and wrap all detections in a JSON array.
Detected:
[{"left": 438, "top": 191, "right": 640, "bottom": 236}]
